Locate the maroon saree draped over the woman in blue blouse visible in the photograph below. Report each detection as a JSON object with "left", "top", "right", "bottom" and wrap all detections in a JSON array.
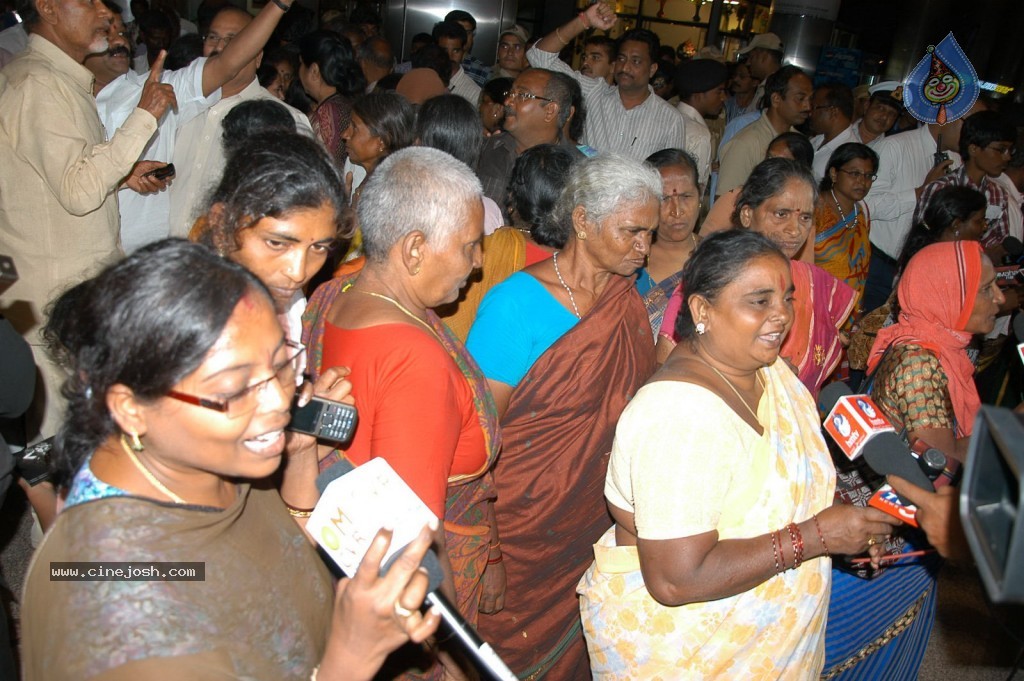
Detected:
[{"left": 479, "top": 276, "right": 655, "bottom": 679}]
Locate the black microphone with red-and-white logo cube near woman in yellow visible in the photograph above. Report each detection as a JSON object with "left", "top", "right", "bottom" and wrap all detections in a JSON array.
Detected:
[{"left": 819, "top": 381, "right": 935, "bottom": 492}]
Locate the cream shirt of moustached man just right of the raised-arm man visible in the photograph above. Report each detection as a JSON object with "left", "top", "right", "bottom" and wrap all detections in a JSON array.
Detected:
[{"left": 170, "top": 79, "right": 313, "bottom": 237}]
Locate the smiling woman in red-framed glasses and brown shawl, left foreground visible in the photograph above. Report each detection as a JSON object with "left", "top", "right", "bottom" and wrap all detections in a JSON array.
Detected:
[{"left": 22, "top": 240, "right": 438, "bottom": 681}]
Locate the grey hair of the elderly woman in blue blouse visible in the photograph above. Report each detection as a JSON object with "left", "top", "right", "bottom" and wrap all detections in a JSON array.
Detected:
[{"left": 554, "top": 154, "right": 662, "bottom": 228}]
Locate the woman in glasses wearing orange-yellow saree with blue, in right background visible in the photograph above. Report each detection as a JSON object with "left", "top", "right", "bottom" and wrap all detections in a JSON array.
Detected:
[{"left": 814, "top": 142, "right": 879, "bottom": 300}]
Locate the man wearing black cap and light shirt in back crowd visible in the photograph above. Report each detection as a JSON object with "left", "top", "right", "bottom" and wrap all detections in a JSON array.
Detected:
[{"left": 676, "top": 59, "right": 729, "bottom": 186}]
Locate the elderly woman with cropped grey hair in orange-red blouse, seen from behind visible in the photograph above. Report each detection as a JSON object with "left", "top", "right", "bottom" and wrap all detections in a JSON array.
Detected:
[{"left": 303, "top": 146, "right": 505, "bottom": 676}]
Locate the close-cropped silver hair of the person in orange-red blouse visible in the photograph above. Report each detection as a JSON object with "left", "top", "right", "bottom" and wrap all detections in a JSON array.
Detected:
[{"left": 356, "top": 146, "right": 483, "bottom": 262}]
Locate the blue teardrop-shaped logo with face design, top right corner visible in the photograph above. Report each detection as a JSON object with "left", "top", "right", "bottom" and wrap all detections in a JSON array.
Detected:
[{"left": 903, "top": 32, "right": 981, "bottom": 125}]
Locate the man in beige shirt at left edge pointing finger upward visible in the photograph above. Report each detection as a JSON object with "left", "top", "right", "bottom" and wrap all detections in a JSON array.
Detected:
[{"left": 0, "top": 0, "right": 174, "bottom": 439}]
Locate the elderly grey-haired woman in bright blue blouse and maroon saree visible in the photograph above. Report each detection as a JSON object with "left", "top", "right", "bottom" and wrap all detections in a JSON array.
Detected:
[{"left": 467, "top": 155, "right": 662, "bottom": 679}]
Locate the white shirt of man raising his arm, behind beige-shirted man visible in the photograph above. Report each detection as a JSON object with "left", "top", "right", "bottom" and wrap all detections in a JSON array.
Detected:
[{"left": 96, "top": 57, "right": 220, "bottom": 253}]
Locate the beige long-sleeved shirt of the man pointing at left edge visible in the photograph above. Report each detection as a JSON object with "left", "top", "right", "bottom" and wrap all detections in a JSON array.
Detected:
[{"left": 0, "top": 35, "right": 157, "bottom": 334}]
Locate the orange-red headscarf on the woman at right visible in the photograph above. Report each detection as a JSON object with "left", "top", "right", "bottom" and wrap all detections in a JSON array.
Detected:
[{"left": 867, "top": 242, "right": 984, "bottom": 436}]
